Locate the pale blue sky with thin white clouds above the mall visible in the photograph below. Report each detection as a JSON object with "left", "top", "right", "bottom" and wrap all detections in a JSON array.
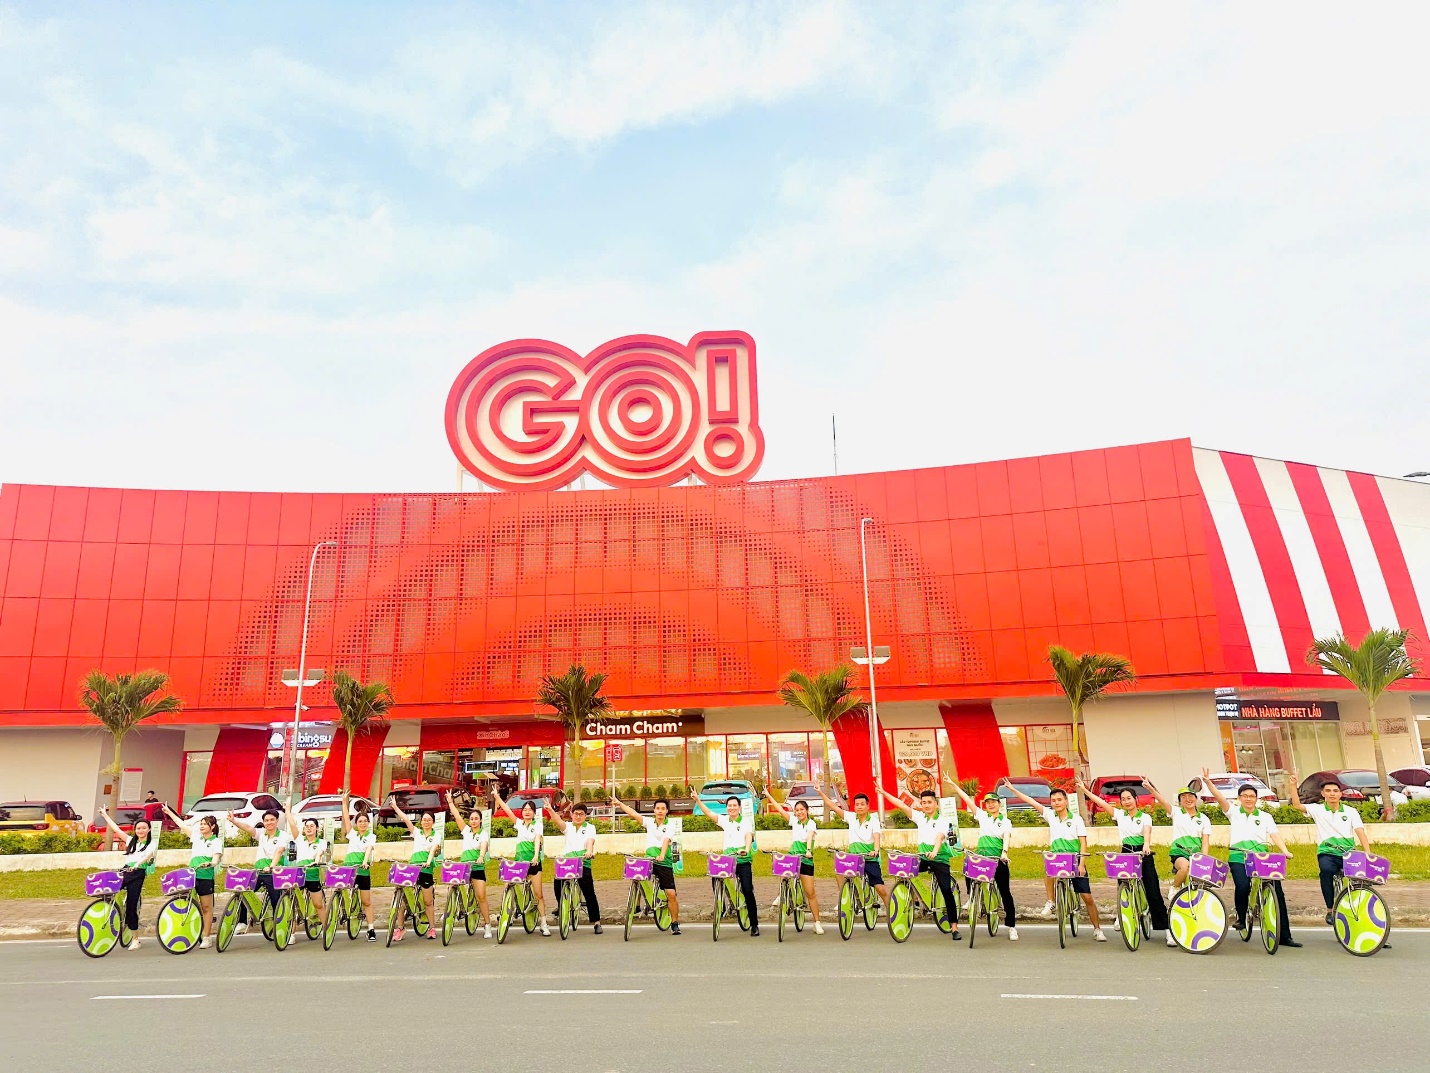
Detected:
[{"left": 0, "top": 0, "right": 1430, "bottom": 491}]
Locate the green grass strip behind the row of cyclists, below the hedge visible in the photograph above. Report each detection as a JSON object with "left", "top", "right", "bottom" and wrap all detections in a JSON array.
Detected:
[{"left": 0, "top": 846, "right": 1430, "bottom": 898}]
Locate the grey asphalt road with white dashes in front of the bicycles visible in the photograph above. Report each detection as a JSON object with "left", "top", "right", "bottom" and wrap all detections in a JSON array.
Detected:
[{"left": 0, "top": 924, "right": 1430, "bottom": 1073}]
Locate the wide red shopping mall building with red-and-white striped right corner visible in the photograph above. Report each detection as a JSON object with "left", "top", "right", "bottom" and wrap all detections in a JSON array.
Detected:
[{"left": 0, "top": 439, "right": 1430, "bottom": 817}]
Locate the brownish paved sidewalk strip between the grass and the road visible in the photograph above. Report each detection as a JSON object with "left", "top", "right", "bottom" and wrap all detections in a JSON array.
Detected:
[{"left": 0, "top": 876, "right": 1430, "bottom": 939}]
